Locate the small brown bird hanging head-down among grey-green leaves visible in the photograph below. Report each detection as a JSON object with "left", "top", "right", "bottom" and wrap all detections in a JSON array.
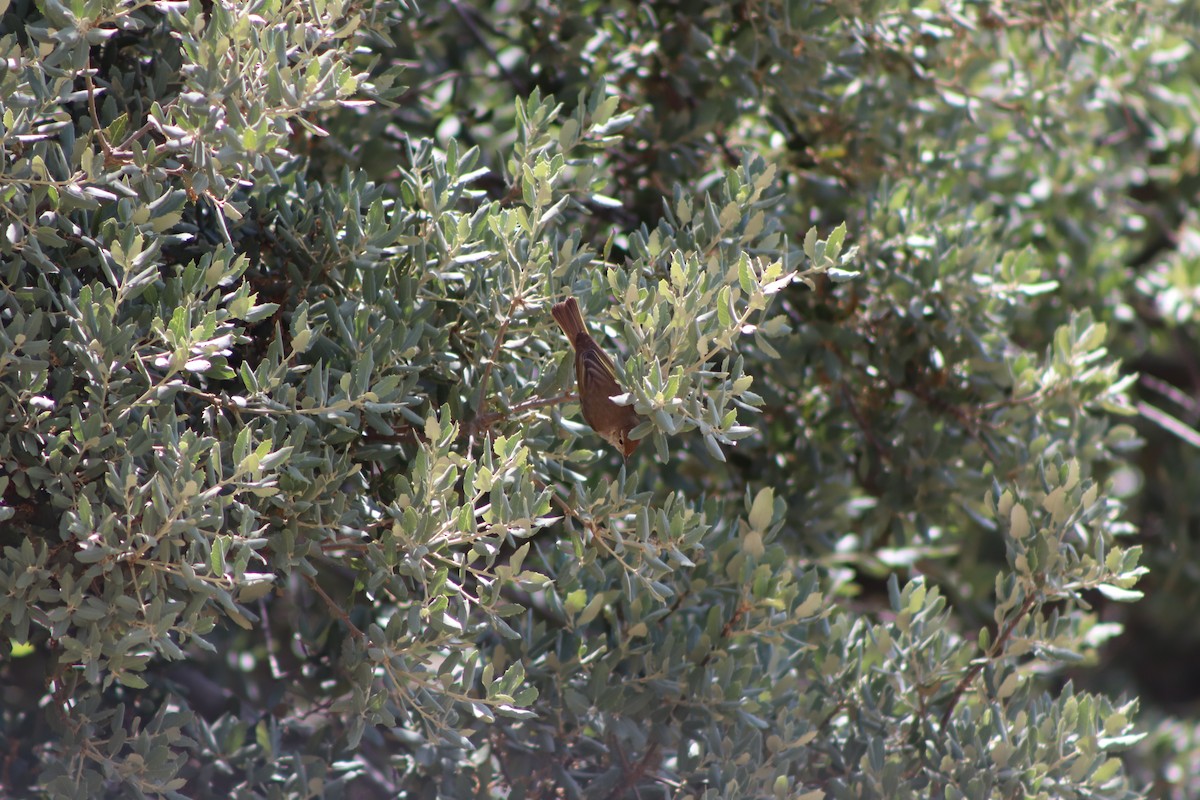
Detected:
[{"left": 550, "top": 297, "right": 642, "bottom": 458}]
